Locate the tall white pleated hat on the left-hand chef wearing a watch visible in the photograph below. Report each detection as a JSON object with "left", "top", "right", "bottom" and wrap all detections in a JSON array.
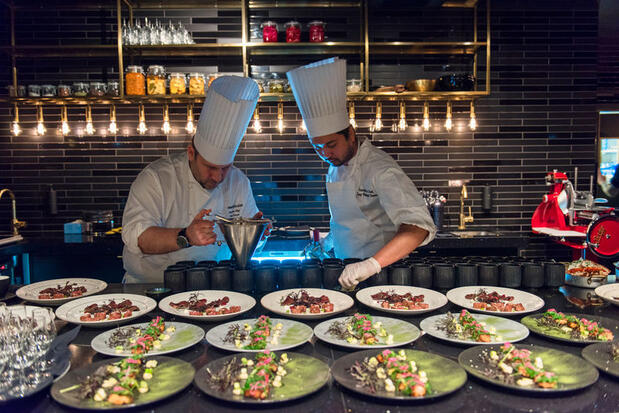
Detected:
[{"left": 194, "top": 76, "right": 260, "bottom": 165}]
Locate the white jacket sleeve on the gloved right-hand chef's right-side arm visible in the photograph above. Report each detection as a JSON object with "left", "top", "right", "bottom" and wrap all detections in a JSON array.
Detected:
[{"left": 374, "top": 168, "right": 436, "bottom": 246}]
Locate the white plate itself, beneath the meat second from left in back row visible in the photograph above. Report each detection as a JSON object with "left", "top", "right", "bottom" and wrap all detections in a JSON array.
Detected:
[{"left": 56, "top": 293, "right": 157, "bottom": 328}]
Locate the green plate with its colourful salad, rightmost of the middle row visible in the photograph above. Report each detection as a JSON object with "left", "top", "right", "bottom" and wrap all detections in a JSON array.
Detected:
[{"left": 520, "top": 308, "right": 619, "bottom": 344}]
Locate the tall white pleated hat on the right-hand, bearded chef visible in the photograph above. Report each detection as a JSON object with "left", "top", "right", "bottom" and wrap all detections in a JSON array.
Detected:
[{"left": 286, "top": 57, "right": 348, "bottom": 138}]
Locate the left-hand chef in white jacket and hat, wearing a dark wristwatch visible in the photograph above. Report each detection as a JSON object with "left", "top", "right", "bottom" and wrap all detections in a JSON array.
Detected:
[{"left": 122, "top": 76, "right": 262, "bottom": 283}]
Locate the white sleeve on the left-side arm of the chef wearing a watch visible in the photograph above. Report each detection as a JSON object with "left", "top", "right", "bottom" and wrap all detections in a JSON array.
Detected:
[{"left": 122, "top": 169, "right": 163, "bottom": 255}]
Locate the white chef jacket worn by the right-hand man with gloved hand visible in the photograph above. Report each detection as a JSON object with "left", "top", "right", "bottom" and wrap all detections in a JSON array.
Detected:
[{"left": 324, "top": 140, "right": 436, "bottom": 258}]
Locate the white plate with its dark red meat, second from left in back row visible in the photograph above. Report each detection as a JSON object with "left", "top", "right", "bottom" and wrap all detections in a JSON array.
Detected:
[{"left": 56, "top": 293, "right": 157, "bottom": 328}]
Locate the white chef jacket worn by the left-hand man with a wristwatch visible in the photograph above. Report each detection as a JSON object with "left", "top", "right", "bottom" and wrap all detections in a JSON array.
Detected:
[{"left": 122, "top": 151, "right": 258, "bottom": 283}]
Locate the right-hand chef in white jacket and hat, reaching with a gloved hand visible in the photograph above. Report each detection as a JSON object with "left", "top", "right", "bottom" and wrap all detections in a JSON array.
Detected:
[{"left": 287, "top": 58, "right": 436, "bottom": 289}]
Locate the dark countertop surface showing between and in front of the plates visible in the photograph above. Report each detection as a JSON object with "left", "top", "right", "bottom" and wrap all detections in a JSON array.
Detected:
[{"left": 2, "top": 284, "right": 619, "bottom": 413}]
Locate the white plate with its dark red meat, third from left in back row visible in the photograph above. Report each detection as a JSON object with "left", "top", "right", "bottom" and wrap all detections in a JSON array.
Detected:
[{"left": 159, "top": 290, "right": 256, "bottom": 322}]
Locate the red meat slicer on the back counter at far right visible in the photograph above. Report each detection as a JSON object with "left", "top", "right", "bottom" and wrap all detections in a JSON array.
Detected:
[{"left": 531, "top": 169, "right": 619, "bottom": 260}]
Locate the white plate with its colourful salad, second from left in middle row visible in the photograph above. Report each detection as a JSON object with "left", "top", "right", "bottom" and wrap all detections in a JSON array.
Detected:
[{"left": 206, "top": 315, "right": 313, "bottom": 352}]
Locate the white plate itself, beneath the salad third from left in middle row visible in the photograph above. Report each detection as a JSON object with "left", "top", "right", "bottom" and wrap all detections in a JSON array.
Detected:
[{"left": 314, "top": 316, "right": 421, "bottom": 349}]
